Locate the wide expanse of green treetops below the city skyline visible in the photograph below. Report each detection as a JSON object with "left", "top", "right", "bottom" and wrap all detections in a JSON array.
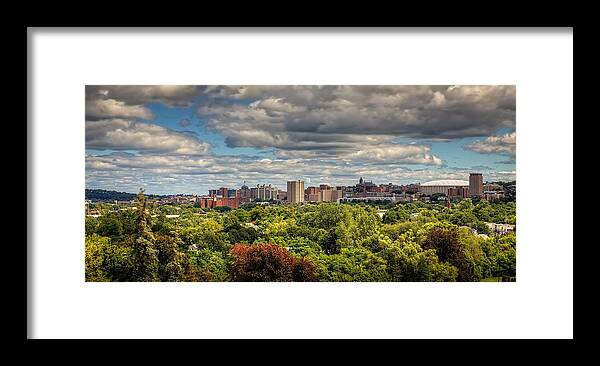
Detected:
[{"left": 85, "top": 190, "right": 516, "bottom": 282}]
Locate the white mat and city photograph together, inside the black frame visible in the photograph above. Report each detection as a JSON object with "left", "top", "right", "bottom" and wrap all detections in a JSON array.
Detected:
[{"left": 28, "top": 28, "right": 573, "bottom": 339}]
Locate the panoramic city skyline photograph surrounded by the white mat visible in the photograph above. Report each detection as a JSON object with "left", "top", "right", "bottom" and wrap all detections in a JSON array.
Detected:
[{"left": 81, "top": 84, "right": 517, "bottom": 282}]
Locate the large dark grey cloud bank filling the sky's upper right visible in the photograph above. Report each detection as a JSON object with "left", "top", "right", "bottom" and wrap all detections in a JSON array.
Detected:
[{"left": 198, "top": 86, "right": 516, "bottom": 150}]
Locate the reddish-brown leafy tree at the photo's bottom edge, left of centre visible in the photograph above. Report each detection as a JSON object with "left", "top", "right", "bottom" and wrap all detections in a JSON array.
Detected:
[{"left": 229, "top": 244, "right": 315, "bottom": 282}]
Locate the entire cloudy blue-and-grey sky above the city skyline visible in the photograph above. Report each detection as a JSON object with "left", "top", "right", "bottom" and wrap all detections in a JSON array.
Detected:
[{"left": 85, "top": 85, "right": 516, "bottom": 194}]
